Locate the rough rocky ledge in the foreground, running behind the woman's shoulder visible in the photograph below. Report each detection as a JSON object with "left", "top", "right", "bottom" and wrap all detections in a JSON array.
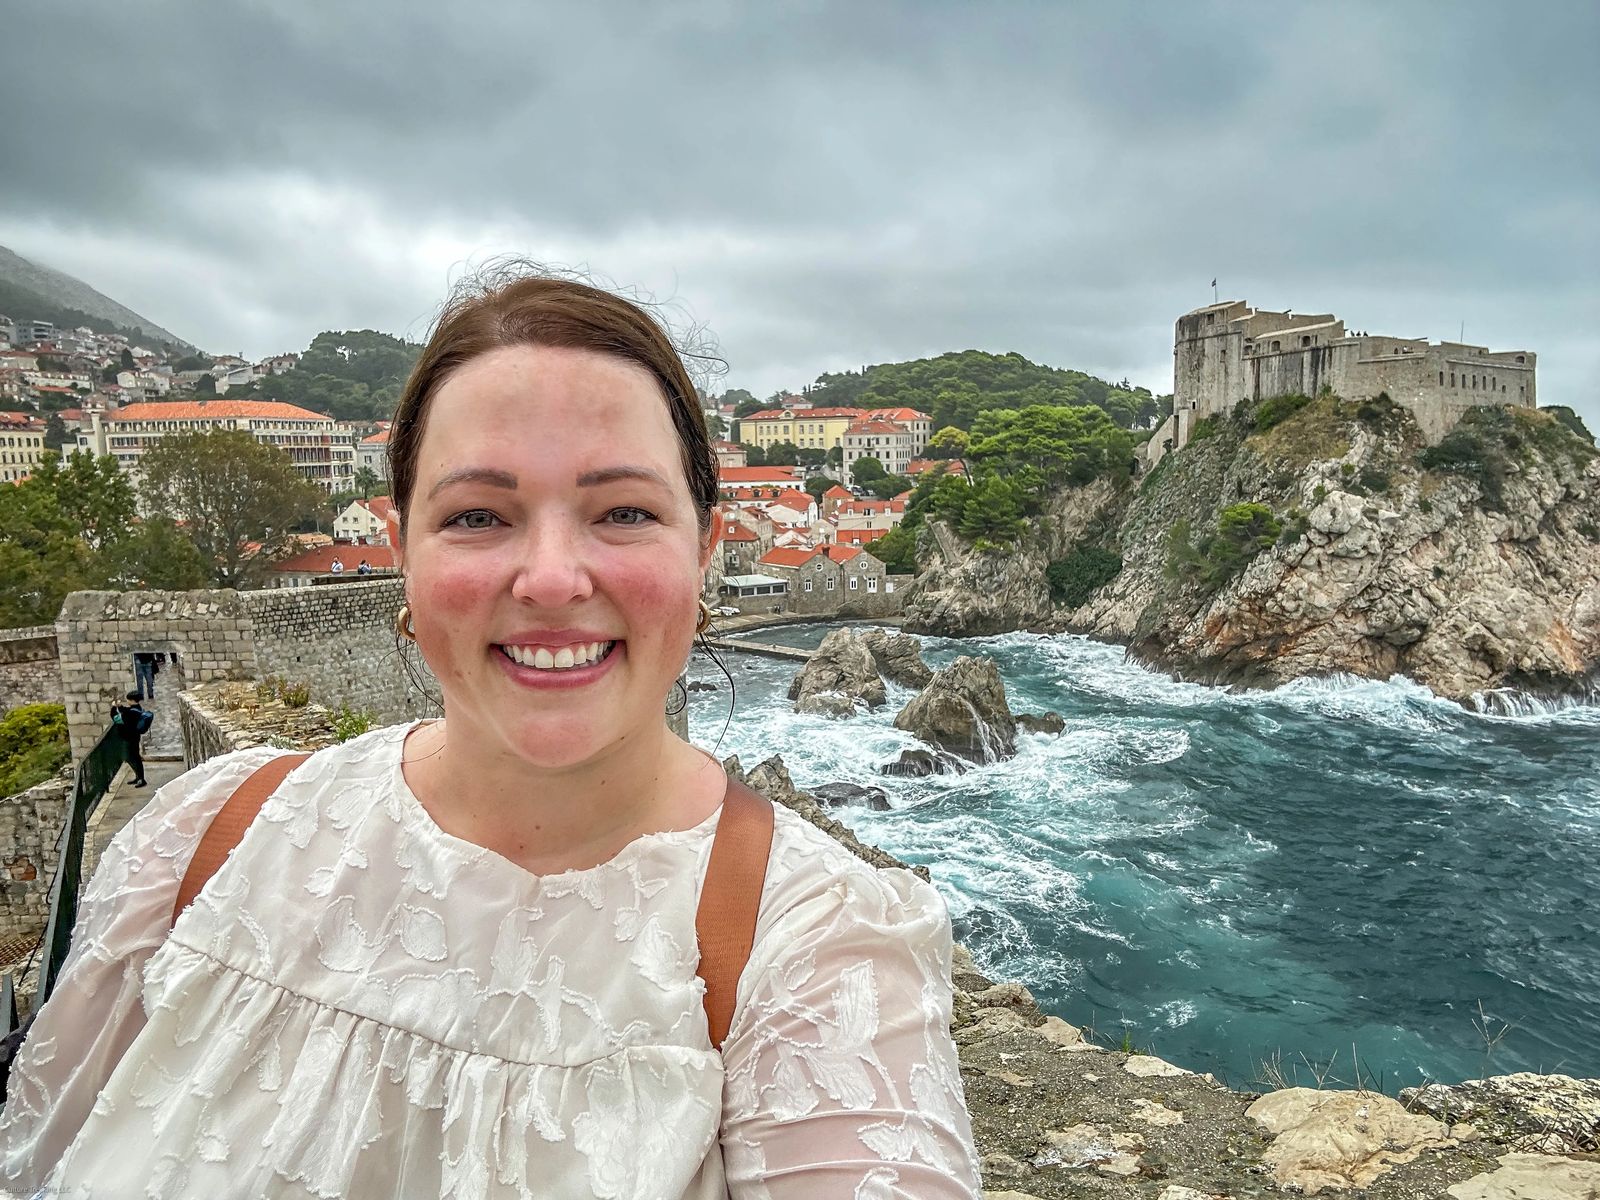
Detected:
[{"left": 725, "top": 757, "right": 1600, "bottom": 1200}]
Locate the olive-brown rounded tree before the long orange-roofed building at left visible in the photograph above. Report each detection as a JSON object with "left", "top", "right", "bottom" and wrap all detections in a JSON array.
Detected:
[{"left": 142, "top": 429, "right": 326, "bottom": 587}]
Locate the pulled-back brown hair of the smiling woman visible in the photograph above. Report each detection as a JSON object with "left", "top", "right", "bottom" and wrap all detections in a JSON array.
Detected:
[{"left": 389, "top": 272, "right": 717, "bottom": 533}]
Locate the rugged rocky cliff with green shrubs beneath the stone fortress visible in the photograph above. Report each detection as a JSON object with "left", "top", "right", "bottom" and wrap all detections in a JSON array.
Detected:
[{"left": 906, "top": 395, "right": 1600, "bottom": 702}]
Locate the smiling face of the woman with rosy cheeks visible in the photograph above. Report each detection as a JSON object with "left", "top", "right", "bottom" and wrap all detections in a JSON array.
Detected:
[{"left": 402, "top": 346, "right": 710, "bottom": 768}]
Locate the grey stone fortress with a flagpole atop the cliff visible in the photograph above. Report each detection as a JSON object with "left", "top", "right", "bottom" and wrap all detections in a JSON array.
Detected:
[{"left": 1142, "top": 301, "right": 1538, "bottom": 469}]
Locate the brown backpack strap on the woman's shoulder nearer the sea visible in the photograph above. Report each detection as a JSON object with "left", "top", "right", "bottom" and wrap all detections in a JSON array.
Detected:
[{"left": 694, "top": 779, "right": 773, "bottom": 1050}]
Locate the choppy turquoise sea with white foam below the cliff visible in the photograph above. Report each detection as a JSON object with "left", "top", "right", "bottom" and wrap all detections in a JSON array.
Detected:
[{"left": 690, "top": 626, "right": 1600, "bottom": 1093}]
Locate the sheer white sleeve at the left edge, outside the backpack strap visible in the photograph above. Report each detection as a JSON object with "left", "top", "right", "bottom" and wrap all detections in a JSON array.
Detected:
[{"left": 0, "top": 747, "right": 282, "bottom": 1195}]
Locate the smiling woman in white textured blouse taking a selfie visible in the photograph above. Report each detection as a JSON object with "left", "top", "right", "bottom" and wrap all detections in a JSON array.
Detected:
[{"left": 0, "top": 278, "right": 979, "bottom": 1200}]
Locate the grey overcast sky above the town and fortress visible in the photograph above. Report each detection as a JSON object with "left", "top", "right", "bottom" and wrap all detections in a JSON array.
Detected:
[{"left": 0, "top": 0, "right": 1600, "bottom": 427}]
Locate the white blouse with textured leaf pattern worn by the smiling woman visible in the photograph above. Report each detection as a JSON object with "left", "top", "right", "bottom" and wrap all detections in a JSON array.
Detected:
[{"left": 0, "top": 726, "right": 981, "bottom": 1200}]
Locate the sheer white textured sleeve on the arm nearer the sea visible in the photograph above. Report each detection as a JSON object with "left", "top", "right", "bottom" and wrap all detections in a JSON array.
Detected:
[{"left": 722, "top": 825, "right": 982, "bottom": 1200}]
